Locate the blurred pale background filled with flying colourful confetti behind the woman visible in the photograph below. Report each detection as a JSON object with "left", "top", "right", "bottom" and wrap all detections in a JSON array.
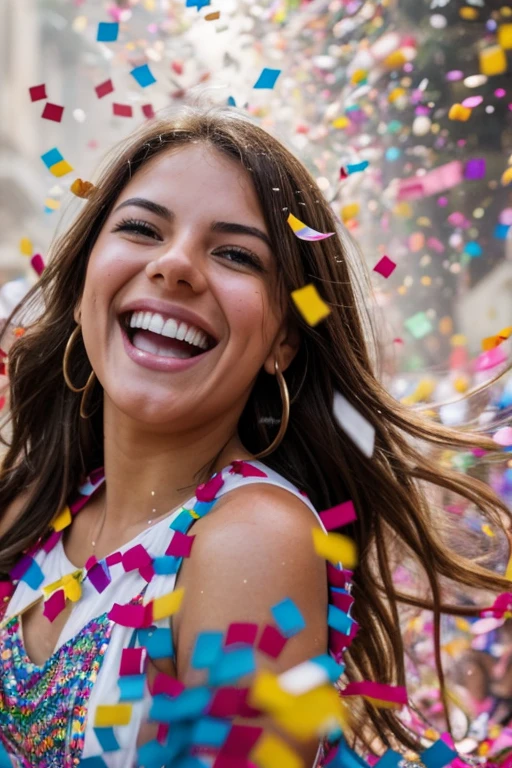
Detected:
[{"left": 0, "top": 0, "right": 512, "bottom": 752}]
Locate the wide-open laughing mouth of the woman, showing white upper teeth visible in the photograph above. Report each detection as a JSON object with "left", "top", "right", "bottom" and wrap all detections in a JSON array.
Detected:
[{"left": 120, "top": 311, "right": 217, "bottom": 360}]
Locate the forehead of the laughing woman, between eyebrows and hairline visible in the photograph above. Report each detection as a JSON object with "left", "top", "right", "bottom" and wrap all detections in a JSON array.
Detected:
[{"left": 114, "top": 142, "right": 263, "bottom": 224}]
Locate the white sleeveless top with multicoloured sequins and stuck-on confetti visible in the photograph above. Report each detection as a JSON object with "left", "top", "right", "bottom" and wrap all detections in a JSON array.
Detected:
[{"left": 0, "top": 461, "right": 348, "bottom": 768}]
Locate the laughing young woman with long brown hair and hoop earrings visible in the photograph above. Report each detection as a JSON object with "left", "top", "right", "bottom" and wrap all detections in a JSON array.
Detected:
[{"left": 0, "top": 109, "right": 508, "bottom": 768}]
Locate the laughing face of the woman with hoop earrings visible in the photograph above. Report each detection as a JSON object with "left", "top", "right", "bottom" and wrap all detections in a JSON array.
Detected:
[{"left": 76, "top": 143, "right": 293, "bottom": 431}]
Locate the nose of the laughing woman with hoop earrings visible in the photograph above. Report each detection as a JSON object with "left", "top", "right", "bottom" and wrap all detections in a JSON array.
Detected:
[{"left": 146, "top": 236, "right": 207, "bottom": 293}]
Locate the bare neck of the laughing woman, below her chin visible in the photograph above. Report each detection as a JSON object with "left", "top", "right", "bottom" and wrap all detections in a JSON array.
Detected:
[{"left": 97, "top": 398, "right": 250, "bottom": 529}]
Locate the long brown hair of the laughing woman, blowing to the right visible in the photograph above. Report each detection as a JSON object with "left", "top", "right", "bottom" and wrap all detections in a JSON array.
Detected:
[{"left": 0, "top": 108, "right": 508, "bottom": 746}]
